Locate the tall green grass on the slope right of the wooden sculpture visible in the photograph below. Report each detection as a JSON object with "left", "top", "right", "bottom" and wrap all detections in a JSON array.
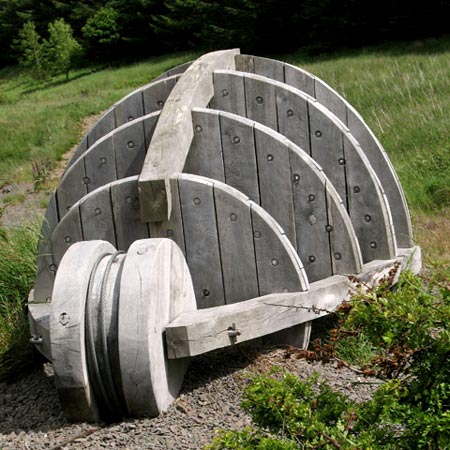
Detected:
[{"left": 284, "top": 38, "right": 450, "bottom": 212}]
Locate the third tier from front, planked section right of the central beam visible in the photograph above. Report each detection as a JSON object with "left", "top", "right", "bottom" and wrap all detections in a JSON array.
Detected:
[{"left": 211, "top": 70, "right": 397, "bottom": 262}]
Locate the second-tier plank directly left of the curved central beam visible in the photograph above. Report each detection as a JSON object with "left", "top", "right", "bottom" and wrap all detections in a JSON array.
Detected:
[{"left": 112, "top": 119, "right": 147, "bottom": 180}]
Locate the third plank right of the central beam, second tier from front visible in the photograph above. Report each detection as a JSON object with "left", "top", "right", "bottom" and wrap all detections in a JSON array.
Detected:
[{"left": 255, "top": 125, "right": 297, "bottom": 247}]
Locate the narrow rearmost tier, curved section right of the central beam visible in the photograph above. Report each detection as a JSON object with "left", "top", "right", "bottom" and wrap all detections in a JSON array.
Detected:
[{"left": 236, "top": 55, "right": 412, "bottom": 247}]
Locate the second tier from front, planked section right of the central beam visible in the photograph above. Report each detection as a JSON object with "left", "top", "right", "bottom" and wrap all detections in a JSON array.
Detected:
[{"left": 185, "top": 108, "right": 362, "bottom": 282}]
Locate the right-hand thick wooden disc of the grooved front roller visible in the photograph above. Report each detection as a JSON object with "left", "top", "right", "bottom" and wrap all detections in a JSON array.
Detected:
[{"left": 118, "top": 239, "right": 195, "bottom": 417}]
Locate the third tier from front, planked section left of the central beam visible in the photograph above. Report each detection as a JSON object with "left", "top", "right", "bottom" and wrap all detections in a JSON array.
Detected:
[{"left": 66, "top": 74, "right": 180, "bottom": 171}]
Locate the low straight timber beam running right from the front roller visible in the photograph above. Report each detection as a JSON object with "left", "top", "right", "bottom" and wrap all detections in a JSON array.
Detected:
[{"left": 166, "top": 258, "right": 412, "bottom": 358}]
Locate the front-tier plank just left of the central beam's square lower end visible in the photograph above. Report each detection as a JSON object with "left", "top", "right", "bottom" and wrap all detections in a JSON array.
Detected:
[{"left": 111, "top": 177, "right": 150, "bottom": 251}]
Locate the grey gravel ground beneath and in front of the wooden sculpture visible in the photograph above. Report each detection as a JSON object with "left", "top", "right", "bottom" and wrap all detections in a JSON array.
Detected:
[{"left": 0, "top": 347, "right": 379, "bottom": 450}]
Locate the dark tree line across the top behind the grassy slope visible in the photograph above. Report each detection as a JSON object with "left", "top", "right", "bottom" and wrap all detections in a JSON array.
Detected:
[{"left": 0, "top": 0, "right": 450, "bottom": 74}]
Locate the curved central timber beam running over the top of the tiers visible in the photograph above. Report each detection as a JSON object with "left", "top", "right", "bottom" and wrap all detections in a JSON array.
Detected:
[{"left": 139, "top": 50, "right": 239, "bottom": 222}]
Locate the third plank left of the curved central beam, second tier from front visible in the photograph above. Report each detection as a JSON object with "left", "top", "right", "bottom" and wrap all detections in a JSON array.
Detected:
[{"left": 56, "top": 157, "right": 88, "bottom": 220}]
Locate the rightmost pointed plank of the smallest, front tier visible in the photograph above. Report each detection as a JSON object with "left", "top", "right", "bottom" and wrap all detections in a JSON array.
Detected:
[{"left": 251, "top": 203, "right": 308, "bottom": 295}]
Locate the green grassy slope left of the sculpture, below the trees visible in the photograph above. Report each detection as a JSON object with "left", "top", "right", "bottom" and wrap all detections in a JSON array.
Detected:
[{"left": 0, "top": 53, "right": 196, "bottom": 186}]
